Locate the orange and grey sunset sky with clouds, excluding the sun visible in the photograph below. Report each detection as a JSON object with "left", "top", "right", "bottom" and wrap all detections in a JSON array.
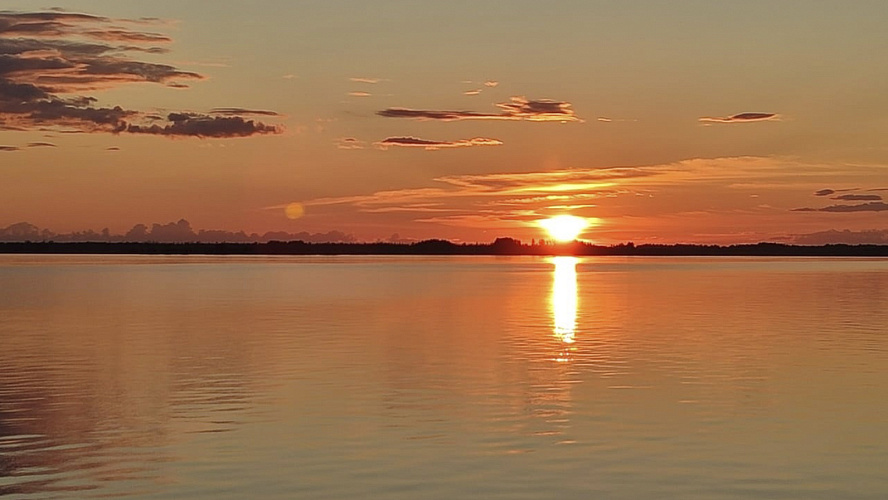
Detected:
[{"left": 0, "top": 0, "right": 888, "bottom": 244}]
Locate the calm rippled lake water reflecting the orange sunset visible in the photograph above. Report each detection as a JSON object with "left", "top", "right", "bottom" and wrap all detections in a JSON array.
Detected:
[{"left": 0, "top": 255, "right": 888, "bottom": 499}]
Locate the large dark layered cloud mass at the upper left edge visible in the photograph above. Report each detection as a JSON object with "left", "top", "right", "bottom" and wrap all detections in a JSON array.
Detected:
[{"left": 0, "top": 11, "right": 281, "bottom": 137}]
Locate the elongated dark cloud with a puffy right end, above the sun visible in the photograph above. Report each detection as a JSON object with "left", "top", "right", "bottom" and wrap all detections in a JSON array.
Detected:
[{"left": 376, "top": 96, "right": 583, "bottom": 122}]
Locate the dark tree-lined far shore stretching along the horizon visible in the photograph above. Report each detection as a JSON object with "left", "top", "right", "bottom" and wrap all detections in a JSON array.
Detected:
[{"left": 0, "top": 238, "right": 888, "bottom": 257}]
